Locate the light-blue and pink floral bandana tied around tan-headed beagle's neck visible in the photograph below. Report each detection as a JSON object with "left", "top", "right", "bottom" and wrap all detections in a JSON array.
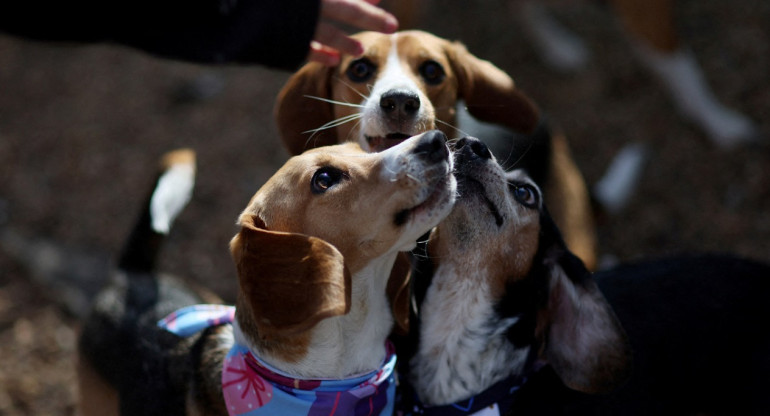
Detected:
[{"left": 158, "top": 305, "right": 396, "bottom": 416}]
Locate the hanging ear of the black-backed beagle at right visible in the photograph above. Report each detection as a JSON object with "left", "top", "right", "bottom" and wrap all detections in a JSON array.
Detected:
[{"left": 541, "top": 253, "right": 631, "bottom": 393}]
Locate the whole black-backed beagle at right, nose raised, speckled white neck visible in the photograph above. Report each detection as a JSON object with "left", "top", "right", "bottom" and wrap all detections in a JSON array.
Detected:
[{"left": 400, "top": 138, "right": 770, "bottom": 415}]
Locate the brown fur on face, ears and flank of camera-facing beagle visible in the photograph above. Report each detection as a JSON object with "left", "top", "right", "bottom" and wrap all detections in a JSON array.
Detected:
[{"left": 275, "top": 31, "right": 597, "bottom": 268}]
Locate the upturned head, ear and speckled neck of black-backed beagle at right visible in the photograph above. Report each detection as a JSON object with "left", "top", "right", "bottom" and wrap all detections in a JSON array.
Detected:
[{"left": 409, "top": 138, "right": 630, "bottom": 414}]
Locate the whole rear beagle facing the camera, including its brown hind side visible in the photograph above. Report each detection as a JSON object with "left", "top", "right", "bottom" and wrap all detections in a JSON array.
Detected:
[{"left": 275, "top": 31, "right": 597, "bottom": 266}]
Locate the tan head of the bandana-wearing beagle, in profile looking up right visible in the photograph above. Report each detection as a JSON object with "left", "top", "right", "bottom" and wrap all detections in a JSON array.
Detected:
[{"left": 230, "top": 131, "right": 455, "bottom": 358}]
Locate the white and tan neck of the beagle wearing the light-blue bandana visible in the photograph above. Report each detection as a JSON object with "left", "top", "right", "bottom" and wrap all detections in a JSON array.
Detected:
[{"left": 236, "top": 252, "right": 397, "bottom": 379}]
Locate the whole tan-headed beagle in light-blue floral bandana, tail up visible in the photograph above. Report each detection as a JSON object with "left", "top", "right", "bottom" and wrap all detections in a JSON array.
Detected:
[{"left": 79, "top": 131, "right": 456, "bottom": 415}]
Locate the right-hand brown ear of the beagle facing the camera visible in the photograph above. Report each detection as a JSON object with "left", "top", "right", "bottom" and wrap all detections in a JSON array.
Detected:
[{"left": 447, "top": 42, "right": 540, "bottom": 134}]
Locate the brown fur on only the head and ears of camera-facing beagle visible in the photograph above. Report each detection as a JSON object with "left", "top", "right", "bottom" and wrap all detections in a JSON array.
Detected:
[{"left": 275, "top": 31, "right": 538, "bottom": 154}]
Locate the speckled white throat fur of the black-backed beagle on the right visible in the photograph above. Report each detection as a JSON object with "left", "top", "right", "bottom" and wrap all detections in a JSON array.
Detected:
[{"left": 411, "top": 262, "right": 530, "bottom": 405}]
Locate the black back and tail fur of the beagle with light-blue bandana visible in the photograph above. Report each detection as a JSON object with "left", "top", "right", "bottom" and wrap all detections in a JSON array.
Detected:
[{"left": 78, "top": 153, "right": 222, "bottom": 416}]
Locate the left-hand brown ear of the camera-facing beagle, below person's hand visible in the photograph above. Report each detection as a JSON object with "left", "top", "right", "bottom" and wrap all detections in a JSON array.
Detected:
[{"left": 274, "top": 62, "right": 338, "bottom": 155}]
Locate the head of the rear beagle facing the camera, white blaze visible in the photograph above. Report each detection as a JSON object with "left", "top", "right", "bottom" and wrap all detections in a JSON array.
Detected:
[{"left": 275, "top": 31, "right": 538, "bottom": 154}]
